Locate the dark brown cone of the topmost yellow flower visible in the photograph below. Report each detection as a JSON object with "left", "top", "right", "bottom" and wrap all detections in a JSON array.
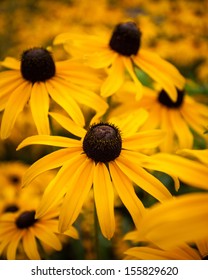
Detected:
[{"left": 109, "top": 22, "right": 141, "bottom": 56}]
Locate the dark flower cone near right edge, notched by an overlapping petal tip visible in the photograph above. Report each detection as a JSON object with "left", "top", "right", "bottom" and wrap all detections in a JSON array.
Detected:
[{"left": 158, "top": 89, "right": 184, "bottom": 108}]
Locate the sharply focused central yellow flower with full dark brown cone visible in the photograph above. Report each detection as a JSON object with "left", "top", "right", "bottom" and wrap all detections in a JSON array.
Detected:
[{"left": 18, "top": 109, "right": 174, "bottom": 239}]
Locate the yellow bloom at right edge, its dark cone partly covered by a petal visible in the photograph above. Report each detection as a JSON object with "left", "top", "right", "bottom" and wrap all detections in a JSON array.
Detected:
[{"left": 109, "top": 83, "right": 208, "bottom": 152}]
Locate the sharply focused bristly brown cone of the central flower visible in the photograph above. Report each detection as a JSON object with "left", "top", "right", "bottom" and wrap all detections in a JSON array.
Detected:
[{"left": 83, "top": 123, "right": 122, "bottom": 162}]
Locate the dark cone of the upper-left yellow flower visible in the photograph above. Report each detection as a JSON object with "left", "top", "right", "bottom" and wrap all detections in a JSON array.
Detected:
[{"left": 21, "top": 48, "right": 56, "bottom": 83}]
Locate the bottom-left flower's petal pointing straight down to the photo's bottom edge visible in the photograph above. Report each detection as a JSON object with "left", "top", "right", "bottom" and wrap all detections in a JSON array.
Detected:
[{"left": 22, "top": 228, "right": 40, "bottom": 260}]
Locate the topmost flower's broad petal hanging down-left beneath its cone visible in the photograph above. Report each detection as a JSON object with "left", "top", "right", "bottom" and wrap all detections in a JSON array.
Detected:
[{"left": 101, "top": 55, "right": 124, "bottom": 97}]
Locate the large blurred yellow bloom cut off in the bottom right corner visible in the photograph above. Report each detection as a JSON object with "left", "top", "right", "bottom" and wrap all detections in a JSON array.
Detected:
[{"left": 125, "top": 192, "right": 208, "bottom": 258}]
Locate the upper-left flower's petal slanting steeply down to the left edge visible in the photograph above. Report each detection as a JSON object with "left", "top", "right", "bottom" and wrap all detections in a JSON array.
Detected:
[{"left": 1, "top": 82, "right": 31, "bottom": 139}]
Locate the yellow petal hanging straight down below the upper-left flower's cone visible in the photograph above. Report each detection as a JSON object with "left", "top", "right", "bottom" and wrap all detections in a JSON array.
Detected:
[{"left": 30, "top": 83, "right": 50, "bottom": 134}]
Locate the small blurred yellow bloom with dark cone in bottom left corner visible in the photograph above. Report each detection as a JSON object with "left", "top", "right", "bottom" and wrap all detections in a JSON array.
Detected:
[{"left": 0, "top": 206, "right": 78, "bottom": 260}]
